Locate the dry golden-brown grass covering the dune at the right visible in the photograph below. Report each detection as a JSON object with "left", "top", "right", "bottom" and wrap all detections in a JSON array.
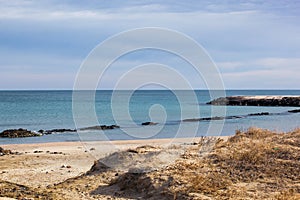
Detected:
[{"left": 97, "top": 128, "right": 300, "bottom": 199}]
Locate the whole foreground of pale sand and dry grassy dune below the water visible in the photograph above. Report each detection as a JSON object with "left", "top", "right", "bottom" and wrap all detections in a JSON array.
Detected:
[{"left": 0, "top": 128, "right": 300, "bottom": 199}]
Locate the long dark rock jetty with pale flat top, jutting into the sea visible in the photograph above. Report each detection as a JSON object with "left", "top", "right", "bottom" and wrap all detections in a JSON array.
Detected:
[{"left": 207, "top": 96, "right": 300, "bottom": 107}]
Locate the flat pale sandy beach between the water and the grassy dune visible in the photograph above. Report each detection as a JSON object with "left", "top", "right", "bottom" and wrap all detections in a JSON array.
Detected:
[{"left": 0, "top": 137, "right": 214, "bottom": 187}]
